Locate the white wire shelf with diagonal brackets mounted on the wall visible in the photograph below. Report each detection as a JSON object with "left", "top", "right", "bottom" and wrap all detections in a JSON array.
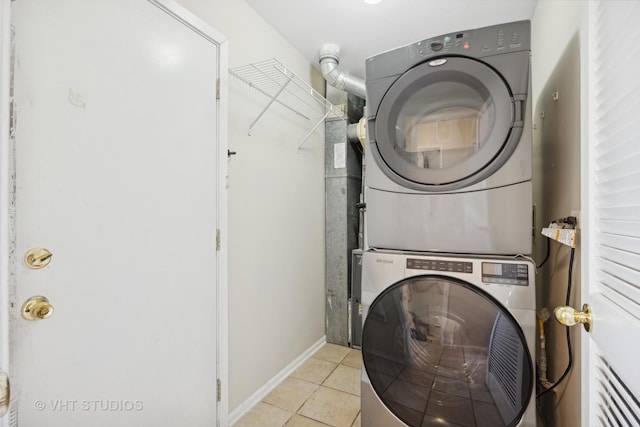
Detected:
[{"left": 229, "top": 59, "right": 343, "bottom": 149}]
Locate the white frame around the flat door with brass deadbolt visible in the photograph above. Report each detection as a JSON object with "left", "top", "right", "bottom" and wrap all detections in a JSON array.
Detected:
[{"left": 0, "top": 0, "right": 229, "bottom": 427}]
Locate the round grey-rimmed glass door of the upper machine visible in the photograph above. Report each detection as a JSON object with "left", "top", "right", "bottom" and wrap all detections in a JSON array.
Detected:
[{"left": 369, "top": 57, "right": 525, "bottom": 191}]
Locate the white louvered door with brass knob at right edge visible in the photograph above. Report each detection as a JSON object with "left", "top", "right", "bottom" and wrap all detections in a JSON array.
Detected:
[{"left": 582, "top": 0, "right": 640, "bottom": 427}]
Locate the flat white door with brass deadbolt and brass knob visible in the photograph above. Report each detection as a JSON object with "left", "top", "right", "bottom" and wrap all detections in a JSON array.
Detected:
[{"left": 10, "top": 0, "right": 226, "bottom": 427}]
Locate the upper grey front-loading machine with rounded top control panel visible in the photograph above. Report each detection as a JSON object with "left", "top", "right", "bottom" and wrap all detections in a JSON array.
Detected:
[{"left": 365, "top": 21, "right": 533, "bottom": 254}]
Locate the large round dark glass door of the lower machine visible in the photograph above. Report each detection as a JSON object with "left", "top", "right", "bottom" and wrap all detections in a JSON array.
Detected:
[{"left": 362, "top": 275, "right": 534, "bottom": 427}]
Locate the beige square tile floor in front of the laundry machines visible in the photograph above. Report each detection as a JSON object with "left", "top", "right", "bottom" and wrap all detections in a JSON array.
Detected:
[{"left": 234, "top": 344, "right": 362, "bottom": 427}]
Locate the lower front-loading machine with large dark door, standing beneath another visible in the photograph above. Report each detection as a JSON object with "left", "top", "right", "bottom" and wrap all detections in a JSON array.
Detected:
[{"left": 361, "top": 250, "right": 537, "bottom": 427}]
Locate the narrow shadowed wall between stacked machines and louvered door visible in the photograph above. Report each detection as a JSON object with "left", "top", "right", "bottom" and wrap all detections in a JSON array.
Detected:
[{"left": 531, "top": 0, "right": 584, "bottom": 427}]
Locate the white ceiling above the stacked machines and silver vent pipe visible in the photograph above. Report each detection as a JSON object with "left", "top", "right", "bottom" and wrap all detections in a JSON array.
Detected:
[{"left": 245, "top": 0, "right": 537, "bottom": 77}]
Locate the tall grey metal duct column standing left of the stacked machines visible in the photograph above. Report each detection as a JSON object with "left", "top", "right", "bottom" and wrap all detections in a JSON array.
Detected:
[{"left": 324, "top": 88, "right": 364, "bottom": 347}]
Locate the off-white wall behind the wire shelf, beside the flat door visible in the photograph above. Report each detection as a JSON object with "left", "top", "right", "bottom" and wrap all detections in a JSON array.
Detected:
[{"left": 179, "top": 0, "right": 325, "bottom": 412}]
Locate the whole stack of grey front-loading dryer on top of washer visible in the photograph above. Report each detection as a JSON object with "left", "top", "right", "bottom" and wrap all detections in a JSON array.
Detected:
[{"left": 361, "top": 21, "right": 536, "bottom": 427}]
